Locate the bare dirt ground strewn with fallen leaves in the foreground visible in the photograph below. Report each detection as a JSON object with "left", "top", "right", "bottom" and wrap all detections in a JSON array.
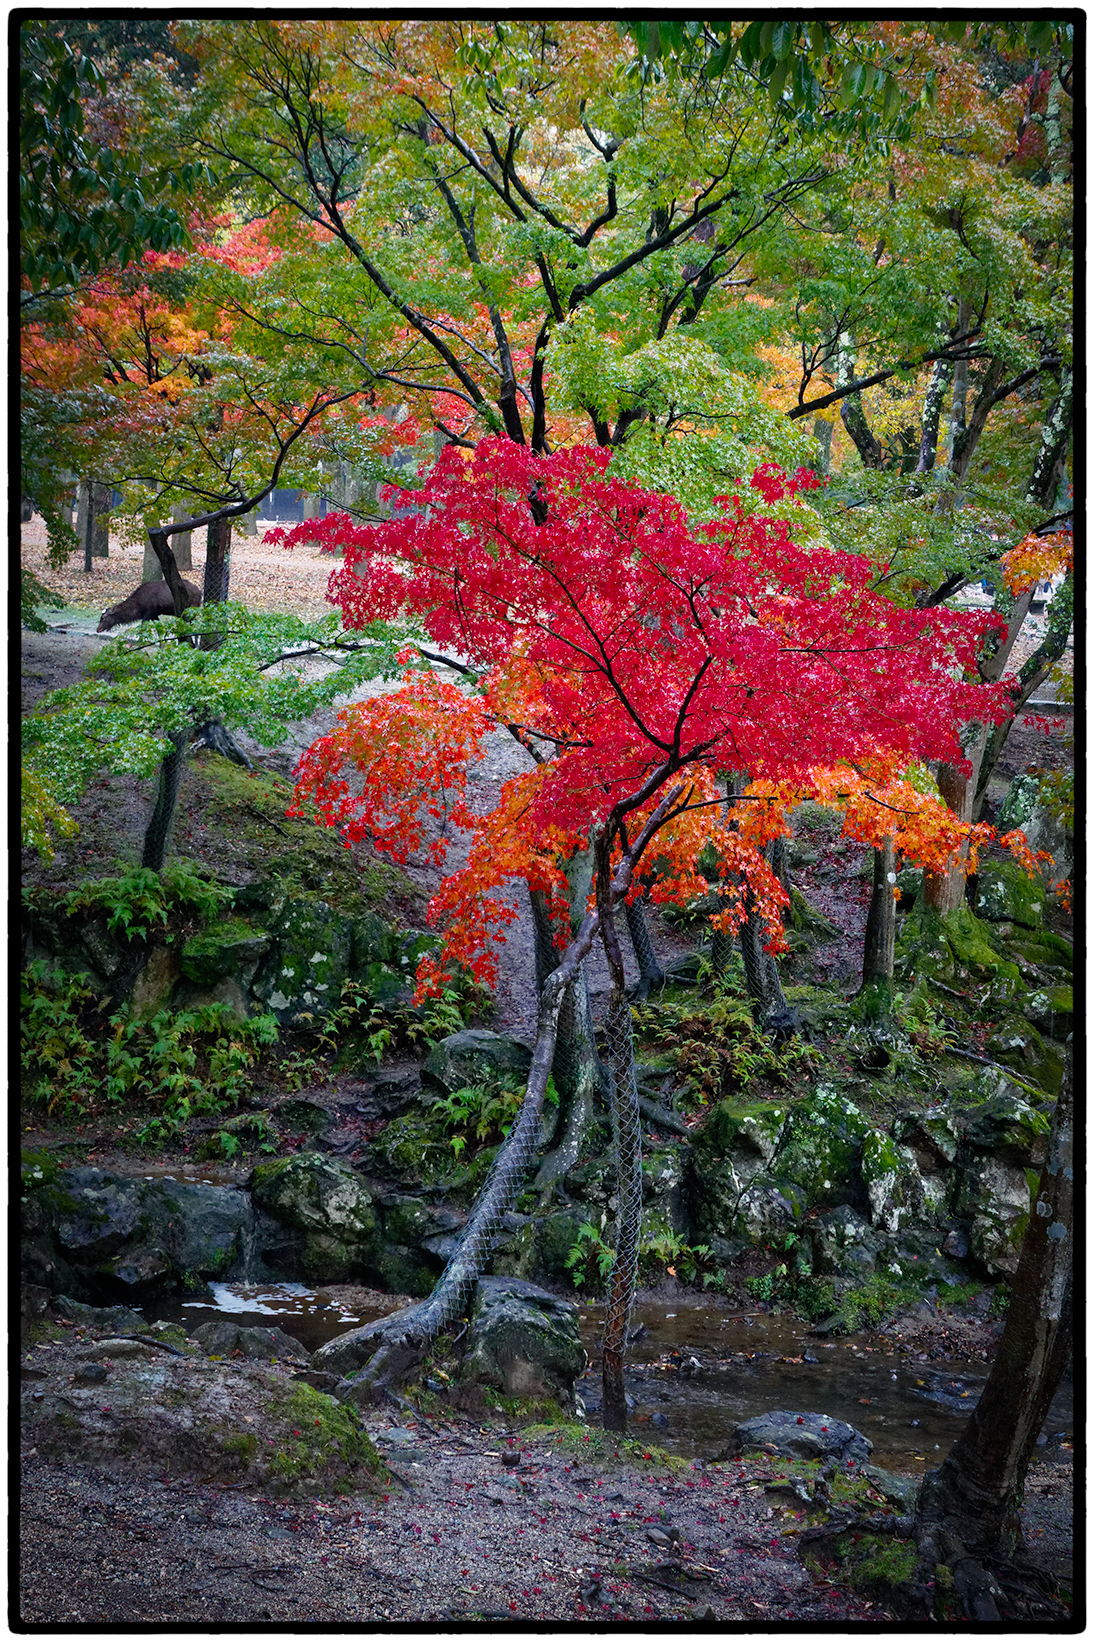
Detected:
[{"left": 13, "top": 1325, "right": 1071, "bottom": 1631}]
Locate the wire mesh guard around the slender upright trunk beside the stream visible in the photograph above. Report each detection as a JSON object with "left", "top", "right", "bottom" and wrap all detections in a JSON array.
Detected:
[{"left": 603, "top": 993, "right": 642, "bottom": 1430}]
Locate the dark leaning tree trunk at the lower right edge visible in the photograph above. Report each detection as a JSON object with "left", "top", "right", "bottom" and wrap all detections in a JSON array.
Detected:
[{"left": 915, "top": 1046, "right": 1074, "bottom": 1621}]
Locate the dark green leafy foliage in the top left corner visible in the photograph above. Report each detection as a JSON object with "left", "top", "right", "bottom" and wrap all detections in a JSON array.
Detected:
[{"left": 18, "top": 23, "right": 207, "bottom": 302}]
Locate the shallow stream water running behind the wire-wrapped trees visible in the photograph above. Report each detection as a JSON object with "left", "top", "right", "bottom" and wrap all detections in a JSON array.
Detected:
[{"left": 145, "top": 1282, "right": 1074, "bottom": 1475}]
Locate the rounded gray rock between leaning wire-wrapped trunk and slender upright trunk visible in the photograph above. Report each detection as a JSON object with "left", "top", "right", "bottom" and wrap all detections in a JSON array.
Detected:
[{"left": 458, "top": 1277, "right": 588, "bottom": 1407}]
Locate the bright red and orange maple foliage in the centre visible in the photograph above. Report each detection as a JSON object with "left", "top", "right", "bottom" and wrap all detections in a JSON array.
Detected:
[{"left": 284, "top": 438, "right": 1002, "bottom": 985}]
